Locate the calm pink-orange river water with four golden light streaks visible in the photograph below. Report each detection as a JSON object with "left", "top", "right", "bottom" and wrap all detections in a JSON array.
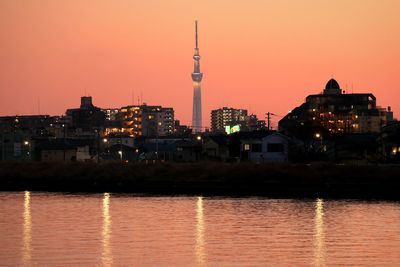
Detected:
[{"left": 0, "top": 192, "right": 400, "bottom": 266}]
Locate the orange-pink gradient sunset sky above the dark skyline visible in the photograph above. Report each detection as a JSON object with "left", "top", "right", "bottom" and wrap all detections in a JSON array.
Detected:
[{"left": 0, "top": 0, "right": 400, "bottom": 129}]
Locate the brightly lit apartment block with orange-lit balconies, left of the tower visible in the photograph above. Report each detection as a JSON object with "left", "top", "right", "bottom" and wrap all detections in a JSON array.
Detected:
[{"left": 116, "top": 104, "right": 174, "bottom": 137}]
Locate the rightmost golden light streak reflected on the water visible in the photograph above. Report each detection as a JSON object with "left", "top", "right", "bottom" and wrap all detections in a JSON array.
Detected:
[{"left": 314, "top": 198, "right": 325, "bottom": 266}]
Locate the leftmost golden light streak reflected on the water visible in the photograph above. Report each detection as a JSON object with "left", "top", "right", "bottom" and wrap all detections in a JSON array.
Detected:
[{"left": 22, "top": 191, "right": 32, "bottom": 266}]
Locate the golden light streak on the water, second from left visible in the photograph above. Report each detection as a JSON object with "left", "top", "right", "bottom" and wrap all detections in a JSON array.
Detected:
[{"left": 101, "top": 193, "right": 113, "bottom": 266}]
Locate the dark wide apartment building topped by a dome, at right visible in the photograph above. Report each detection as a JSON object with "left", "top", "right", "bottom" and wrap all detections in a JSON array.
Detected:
[{"left": 279, "top": 79, "right": 393, "bottom": 136}]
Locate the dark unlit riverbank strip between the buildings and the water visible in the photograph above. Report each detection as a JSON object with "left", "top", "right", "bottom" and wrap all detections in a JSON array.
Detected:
[{"left": 0, "top": 162, "right": 400, "bottom": 200}]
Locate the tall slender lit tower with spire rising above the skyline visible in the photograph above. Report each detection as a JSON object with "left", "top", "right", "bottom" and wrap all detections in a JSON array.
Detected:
[{"left": 192, "top": 20, "right": 203, "bottom": 133}]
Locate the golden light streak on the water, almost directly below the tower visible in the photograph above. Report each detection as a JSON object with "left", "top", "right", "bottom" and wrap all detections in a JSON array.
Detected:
[{"left": 196, "top": 197, "right": 206, "bottom": 265}]
